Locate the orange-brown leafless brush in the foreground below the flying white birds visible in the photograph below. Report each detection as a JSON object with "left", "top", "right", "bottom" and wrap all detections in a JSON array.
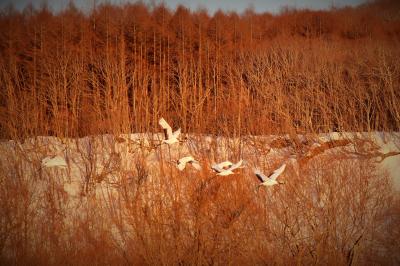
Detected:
[{"left": 0, "top": 140, "right": 399, "bottom": 265}]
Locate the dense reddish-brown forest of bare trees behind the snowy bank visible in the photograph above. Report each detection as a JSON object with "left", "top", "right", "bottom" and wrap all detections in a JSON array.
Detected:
[{"left": 0, "top": 1, "right": 400, "bottom": 138}]
